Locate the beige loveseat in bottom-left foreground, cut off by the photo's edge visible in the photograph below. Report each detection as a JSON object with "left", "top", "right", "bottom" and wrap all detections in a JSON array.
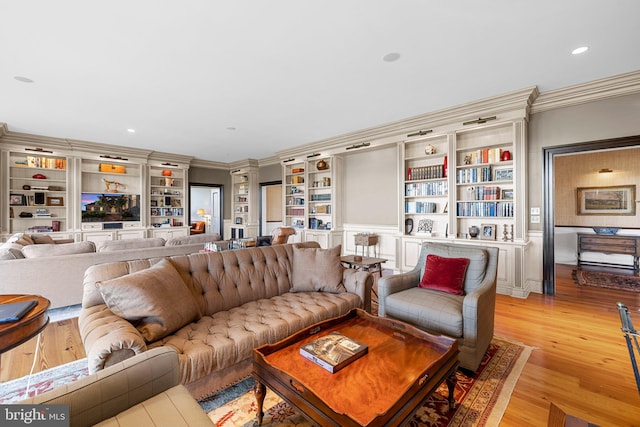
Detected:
[{"left": 18, "top": 347, "right": 214, "bottom": 427}]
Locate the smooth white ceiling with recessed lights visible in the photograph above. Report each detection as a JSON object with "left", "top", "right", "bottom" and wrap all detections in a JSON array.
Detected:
[{"left": 0, "top": 0, "right": 640, "bottom": 162}]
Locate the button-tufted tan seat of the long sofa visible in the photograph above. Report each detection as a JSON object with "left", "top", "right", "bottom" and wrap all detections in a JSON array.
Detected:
[{"left": 149, "top": 292, "right": 362, "bottom": 384}]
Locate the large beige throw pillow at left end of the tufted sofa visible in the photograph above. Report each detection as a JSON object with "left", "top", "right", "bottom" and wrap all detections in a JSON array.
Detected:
[{"left": 96, "top": 259, "right": 200, "bottom": 342}]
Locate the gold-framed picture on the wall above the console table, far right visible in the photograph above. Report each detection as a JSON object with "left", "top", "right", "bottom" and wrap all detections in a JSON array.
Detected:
[{"left": 577, "top": 185, "right": 636, "bottom": 215}]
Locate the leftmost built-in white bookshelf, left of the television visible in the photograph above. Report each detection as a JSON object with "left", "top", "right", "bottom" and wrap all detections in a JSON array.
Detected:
[{"left": 8, "top": 151, "right": 70, "bottom": 233}]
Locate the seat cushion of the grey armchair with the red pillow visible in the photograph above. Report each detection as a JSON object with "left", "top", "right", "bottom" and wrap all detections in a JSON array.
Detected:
[{"left": 385, "top": 287, "right": 464, "bottom": 338}]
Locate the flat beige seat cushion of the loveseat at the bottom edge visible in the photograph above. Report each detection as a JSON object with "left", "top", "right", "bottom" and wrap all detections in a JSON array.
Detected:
[{"left": 96, "top": 385, "right": 214, "bottom": 427}]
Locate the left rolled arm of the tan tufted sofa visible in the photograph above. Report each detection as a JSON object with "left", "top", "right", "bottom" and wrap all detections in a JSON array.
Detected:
[{"left": 78, "top": 304, "right": 147, "bottom": 374}]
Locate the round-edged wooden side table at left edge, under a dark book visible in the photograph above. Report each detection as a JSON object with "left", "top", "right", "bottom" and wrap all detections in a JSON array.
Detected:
[{"left": 0, "top": 295, "right": 50, "bottom": 354}]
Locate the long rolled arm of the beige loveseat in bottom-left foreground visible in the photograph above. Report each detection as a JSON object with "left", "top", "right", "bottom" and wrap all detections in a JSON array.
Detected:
[{"left": 17, "top": 347, "right": 180, "bottom": 427}]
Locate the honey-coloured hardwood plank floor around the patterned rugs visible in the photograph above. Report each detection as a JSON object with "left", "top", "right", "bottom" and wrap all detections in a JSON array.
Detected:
[{"left": 0, "top": 265, "right": 640, "bottom": 427}]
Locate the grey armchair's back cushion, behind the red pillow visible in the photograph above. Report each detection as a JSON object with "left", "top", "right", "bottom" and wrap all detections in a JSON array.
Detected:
[{"left": 418, "top": 242, "right": 489, "bottom": 294}]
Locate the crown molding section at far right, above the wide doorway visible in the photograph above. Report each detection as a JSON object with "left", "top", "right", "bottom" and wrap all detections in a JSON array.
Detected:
[{"left": 531, "top": 71, "right": 640, "bottom": 114}]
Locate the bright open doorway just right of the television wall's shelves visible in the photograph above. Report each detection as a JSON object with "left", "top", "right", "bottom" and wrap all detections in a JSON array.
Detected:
[{"left": 189, "top": 184, "right": 224, "bottom": 238}]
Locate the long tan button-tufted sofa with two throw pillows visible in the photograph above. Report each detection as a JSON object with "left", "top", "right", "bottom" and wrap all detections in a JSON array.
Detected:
[{"left": 79, "top": 242, "right": 373, "bottom": 398}]
